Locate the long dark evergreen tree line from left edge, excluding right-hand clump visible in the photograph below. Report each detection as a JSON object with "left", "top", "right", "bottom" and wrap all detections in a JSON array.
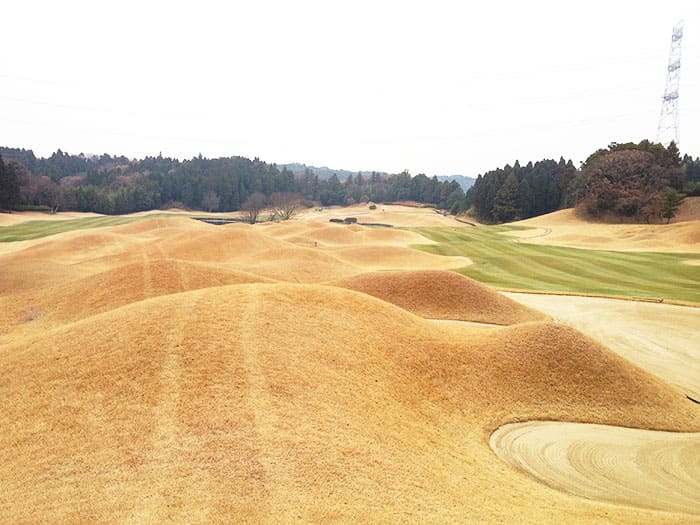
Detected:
[{"left": 0, "top": 148, "right": 466, "bottom": 214}]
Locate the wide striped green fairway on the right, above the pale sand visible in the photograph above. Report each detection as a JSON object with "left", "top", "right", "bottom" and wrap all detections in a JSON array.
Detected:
[{"left": 415, "top": 226, "right": 700, "bottom": 303}]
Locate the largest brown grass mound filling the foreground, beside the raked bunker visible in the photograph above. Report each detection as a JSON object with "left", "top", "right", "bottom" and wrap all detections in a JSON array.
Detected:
[{"left": 0, "top": 284, "right": 700, "bottom": 523}]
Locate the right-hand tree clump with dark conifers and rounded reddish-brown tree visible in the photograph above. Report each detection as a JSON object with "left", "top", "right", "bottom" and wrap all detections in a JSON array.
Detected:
[{"left": 467, "top": 140, "right": 700, "bottom": 223}]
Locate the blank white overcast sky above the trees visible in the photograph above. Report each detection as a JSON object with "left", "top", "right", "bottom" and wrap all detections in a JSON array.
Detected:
[{"left": 0, "top": 0, "right": 700, "bottom": 176}]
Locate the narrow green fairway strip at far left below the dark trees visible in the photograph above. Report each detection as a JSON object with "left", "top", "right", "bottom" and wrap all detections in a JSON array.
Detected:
[{"left": 0, "top": 213, "right": 174, "bottom": 242}]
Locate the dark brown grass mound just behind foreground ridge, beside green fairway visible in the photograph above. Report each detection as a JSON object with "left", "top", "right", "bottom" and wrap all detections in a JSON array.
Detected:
[{"left": 337, "top": 270, "right": 545, "bottom": 325}]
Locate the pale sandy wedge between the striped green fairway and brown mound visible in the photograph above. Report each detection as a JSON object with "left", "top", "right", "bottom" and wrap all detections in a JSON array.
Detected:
[{"left": 504, "top": 293, "right": 700, "bottom": 399}]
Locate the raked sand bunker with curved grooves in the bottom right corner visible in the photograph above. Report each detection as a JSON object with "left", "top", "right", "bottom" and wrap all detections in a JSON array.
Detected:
[{"left": 490, "top": 421, "right": 700, "bottom": 514}]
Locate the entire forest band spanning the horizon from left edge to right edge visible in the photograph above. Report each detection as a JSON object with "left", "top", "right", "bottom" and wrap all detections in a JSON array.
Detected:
[{"left": 0, "top": 140, "right": 700, "bottom": 223}]
